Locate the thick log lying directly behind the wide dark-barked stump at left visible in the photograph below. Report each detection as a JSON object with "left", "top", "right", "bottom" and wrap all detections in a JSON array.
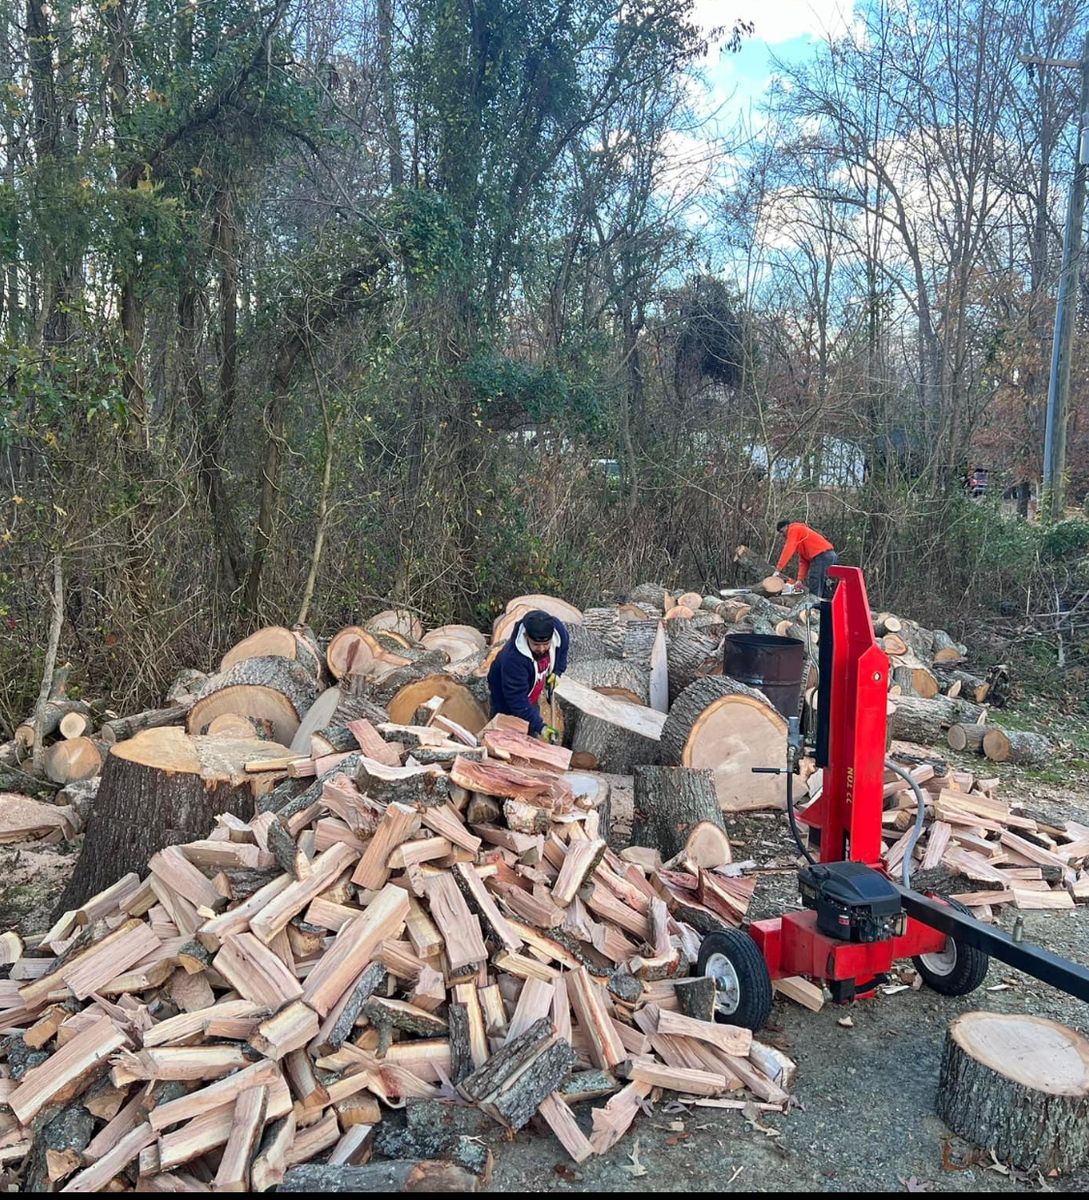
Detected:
[{"left": 186, "top": 656, "right": 318, "bottom": 746}]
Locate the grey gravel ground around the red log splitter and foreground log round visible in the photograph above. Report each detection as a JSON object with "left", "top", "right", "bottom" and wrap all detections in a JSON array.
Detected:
[{"left": 489, "top": 780, "right": 1089, "bottom": 1192}]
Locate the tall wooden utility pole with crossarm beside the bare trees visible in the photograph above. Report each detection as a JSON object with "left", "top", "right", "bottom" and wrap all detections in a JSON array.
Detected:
[{"left": 1019, "top": 32, "right": 1089, "bottom": 521}]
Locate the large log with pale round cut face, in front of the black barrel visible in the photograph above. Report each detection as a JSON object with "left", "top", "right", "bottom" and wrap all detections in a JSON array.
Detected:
[{"left": 661, "top": 676, "right": 787, "bottom": 812}]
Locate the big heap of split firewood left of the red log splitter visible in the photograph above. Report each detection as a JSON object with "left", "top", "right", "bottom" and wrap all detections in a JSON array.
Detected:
[{"left": 0, "top": 718, "right": 789, "bottom": 1192}]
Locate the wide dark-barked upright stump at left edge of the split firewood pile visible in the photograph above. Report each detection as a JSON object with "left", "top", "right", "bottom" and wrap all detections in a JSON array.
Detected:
[{"left": 60, "top": 726, "right": 288, "bottom": 911}]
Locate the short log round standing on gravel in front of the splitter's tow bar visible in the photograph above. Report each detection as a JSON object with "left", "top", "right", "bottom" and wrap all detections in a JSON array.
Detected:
[{"left": 938, "top": 1013, "right": 1089, "bottom": 1174}]
